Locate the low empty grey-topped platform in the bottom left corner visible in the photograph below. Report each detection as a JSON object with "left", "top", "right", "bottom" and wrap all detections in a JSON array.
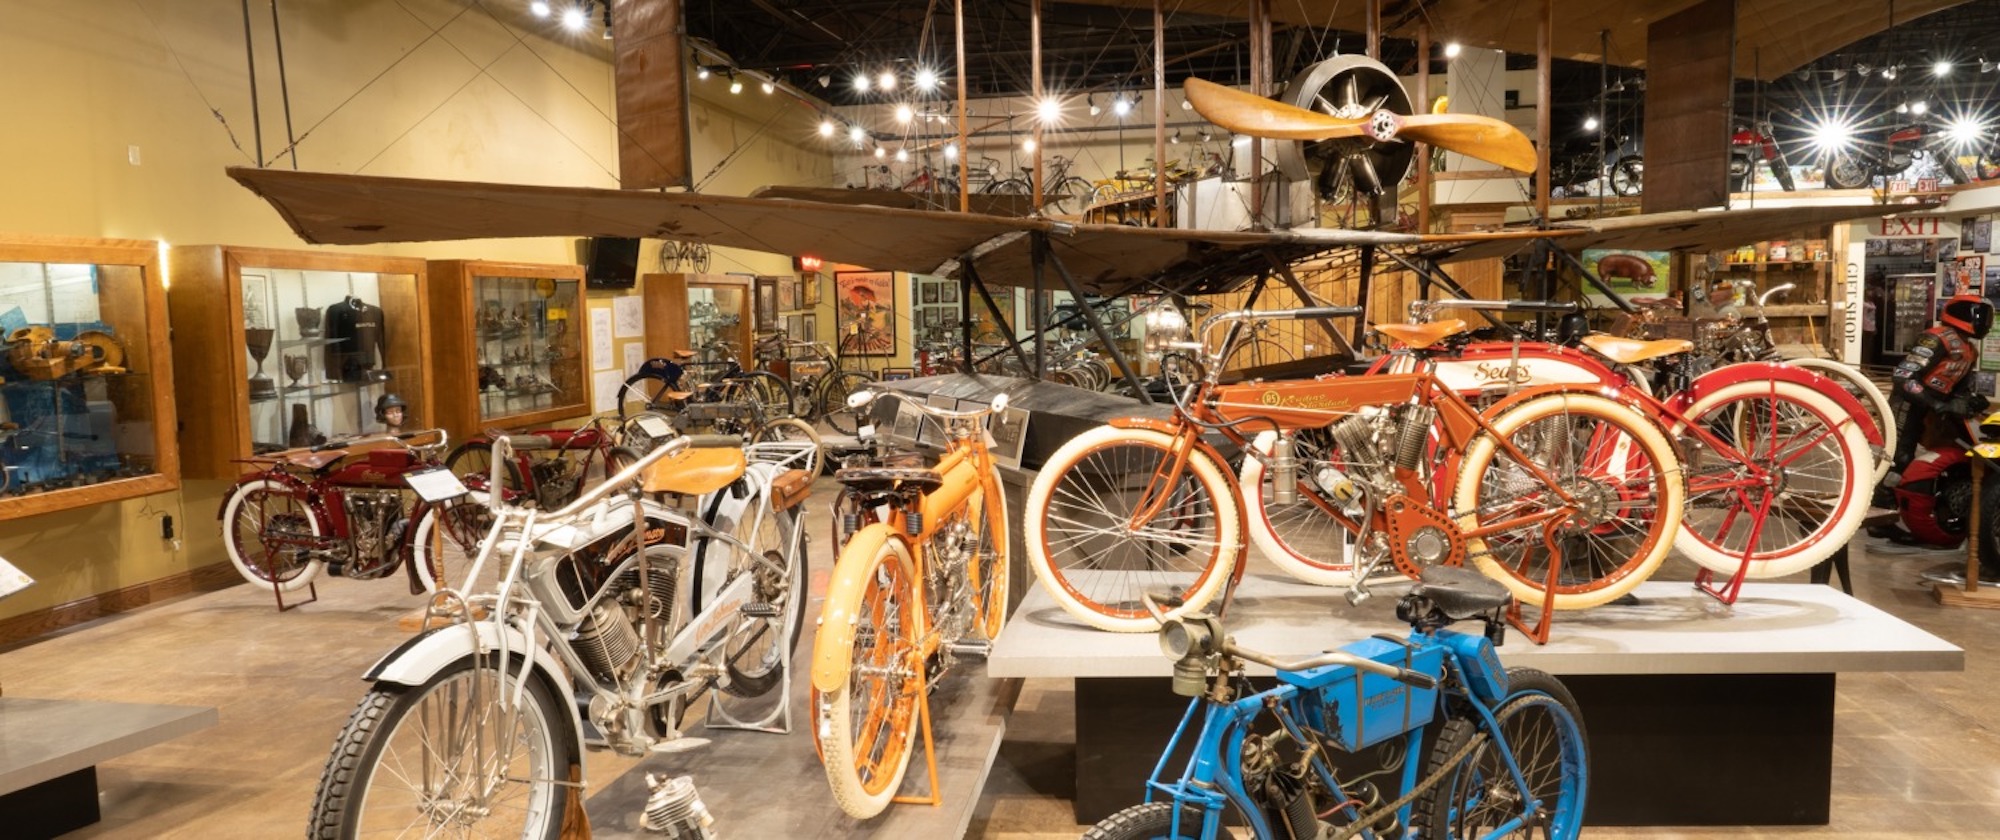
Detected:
[{"left": 0, "top": 698, "right": 218, "bottom": 840}]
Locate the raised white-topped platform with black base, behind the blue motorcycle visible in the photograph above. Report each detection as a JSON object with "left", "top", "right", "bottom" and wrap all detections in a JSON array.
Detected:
[{"left": 988, "top": 574, "right": 1964, "bottom": 826}]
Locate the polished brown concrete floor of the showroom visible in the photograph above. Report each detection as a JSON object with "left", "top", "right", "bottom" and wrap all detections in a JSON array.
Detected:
[{"left": 0, "top": 480, "right": 2000, "bottom": 840}]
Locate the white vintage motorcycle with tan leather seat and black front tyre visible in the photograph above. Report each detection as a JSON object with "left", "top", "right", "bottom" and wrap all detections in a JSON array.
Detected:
[{"left": 308, "top": 418, "right": 812, "bottom": 840}]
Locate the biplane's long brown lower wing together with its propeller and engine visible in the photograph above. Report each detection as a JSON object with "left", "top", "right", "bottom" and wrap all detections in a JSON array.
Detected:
[{"left": 228, "top": 56, "right": 1908, "bottom": 398}]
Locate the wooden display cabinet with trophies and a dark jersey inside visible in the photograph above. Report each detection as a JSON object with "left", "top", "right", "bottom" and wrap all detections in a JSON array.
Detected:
[{"left": 166, "top": 246, "right": 436, "bottom": 480}]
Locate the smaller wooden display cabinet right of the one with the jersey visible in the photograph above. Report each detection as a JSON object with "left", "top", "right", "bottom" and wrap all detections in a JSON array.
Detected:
[{"left": 428, "top": 260, "right": 590, "bottom": 440}]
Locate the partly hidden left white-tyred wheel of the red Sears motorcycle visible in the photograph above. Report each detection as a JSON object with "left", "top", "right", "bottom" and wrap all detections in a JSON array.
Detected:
[{"left": 1240, "top": 428, "right": 1354, "bottom": 586}]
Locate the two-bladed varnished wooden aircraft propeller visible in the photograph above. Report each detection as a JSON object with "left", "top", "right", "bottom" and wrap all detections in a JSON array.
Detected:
[{"left": 1186, "top": 78, "right": 1534, "bottom": 172}]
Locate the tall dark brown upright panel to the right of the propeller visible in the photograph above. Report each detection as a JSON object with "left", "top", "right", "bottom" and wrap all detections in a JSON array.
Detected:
[{"left": 1640, "top": 0, "right": 1736, "bottom": 212}]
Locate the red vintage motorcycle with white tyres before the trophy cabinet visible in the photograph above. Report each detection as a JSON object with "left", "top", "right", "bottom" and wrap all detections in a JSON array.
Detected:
[{"left": 218, "top": 430, "right": 484, "bottom": 606}]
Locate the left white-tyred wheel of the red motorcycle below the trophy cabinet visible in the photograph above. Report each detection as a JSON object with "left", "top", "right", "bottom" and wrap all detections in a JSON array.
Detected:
[{"left": 222, "top": 478, "right": 326, "bottom": 592}]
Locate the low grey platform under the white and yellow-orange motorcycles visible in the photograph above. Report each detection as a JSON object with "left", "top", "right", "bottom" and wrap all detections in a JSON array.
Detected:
[{"left": 584, "top": 644, "right": 1020, "bottom": 840}]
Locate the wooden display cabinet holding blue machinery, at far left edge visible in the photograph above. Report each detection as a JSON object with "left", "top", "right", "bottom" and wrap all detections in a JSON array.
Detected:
[{"left": 0, "top": 236, "right": 180, "bottom": 520}]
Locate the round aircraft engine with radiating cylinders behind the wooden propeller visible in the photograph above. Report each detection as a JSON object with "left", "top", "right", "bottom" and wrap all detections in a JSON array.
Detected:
[{"left": 1278, "top": 56, "right": 1414, "bottom": 200}]
